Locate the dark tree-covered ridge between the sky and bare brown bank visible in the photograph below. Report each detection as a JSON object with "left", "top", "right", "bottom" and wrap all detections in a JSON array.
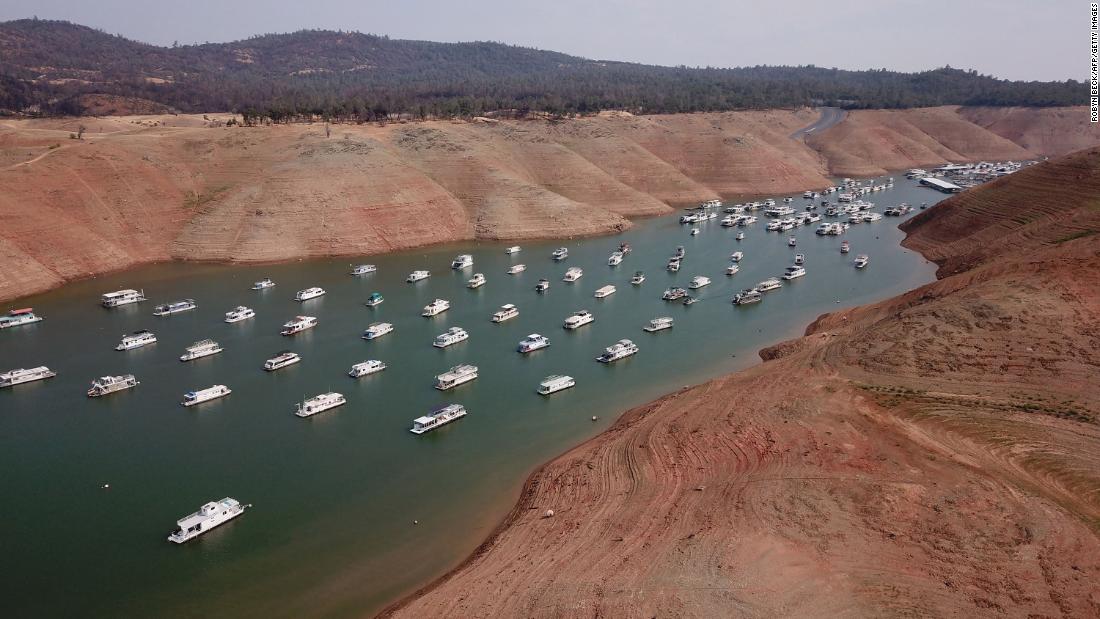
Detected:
[{"left": 0, "top": 20, "right": 1087, "bottom": 121}]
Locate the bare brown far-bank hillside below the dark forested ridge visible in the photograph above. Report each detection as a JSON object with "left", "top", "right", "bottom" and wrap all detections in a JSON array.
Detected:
[{"left": 0, "top": 108, "right": 1100, "bottom": 299}]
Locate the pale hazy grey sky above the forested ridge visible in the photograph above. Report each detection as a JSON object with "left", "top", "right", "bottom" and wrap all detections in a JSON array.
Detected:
[{"left": 0, "top": 0, "right": 1088, "bottom": 80}]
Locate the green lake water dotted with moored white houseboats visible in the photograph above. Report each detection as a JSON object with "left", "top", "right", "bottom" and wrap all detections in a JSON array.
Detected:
[{"left": 0, "top": 179, "right": 942, "bottom": 617}]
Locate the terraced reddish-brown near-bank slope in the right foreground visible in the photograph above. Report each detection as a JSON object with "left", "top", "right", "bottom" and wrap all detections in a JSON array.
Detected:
[{"left": 391, "top": 150, "right": 1100, "bottom": 617}]
